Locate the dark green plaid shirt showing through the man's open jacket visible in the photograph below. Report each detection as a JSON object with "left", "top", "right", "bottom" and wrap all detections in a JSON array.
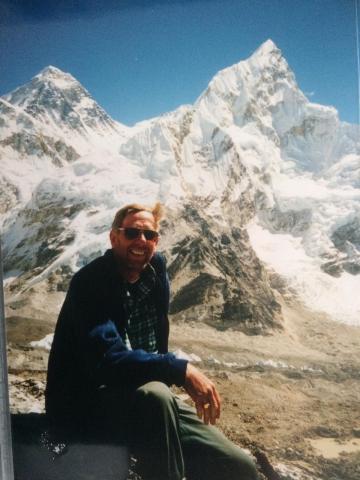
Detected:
[{"left": 124, "top": 264, "right": 158, "bottom": 352}]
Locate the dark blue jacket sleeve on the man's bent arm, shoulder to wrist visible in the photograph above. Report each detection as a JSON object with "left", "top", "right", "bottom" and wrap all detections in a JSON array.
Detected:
[{"left": 65, "top": 270, "right": 187, "bottom": 387}]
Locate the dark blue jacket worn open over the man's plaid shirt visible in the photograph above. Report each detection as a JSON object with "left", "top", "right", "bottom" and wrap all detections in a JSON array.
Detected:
[{"left": 45, "top": 250, "right": 186, "bottom": 419}]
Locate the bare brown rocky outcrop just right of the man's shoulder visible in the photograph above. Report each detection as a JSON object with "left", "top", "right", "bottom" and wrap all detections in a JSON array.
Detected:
[{"left": 168, "top": 205, "right": 281, "bottom": 334}]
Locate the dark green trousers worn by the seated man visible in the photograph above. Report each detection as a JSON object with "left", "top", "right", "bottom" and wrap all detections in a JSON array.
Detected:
[{"left": 127, "top": 382, "right": 258, "bottom": 480}]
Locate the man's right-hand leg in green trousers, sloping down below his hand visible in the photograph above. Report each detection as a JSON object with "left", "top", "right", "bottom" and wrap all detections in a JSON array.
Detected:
[{"left": 178, "top": 401, "right": 258, "bottom": 480}]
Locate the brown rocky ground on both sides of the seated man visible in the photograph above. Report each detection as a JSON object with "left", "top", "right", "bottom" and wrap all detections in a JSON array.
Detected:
[{"left": 8, "top": 301, "right": 360, "bottom": 480}]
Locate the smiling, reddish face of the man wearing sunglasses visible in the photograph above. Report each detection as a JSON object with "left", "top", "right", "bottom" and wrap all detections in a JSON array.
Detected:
[{"left": 110, "top": 211, "right": 158, "bottom": 270}]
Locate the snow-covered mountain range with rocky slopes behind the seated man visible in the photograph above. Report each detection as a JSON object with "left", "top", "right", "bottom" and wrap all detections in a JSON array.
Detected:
[{"left": 0, "top": 40, "right": 360, "bottom": 333}]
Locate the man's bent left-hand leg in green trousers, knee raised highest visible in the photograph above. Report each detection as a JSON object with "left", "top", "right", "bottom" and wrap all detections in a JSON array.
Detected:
[{"left": 131, "top": 382, "right": 185, "bottom": 480}]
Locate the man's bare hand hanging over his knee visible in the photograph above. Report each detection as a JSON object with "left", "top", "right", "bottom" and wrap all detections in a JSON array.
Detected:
[{"left": 184, "top": 363, "right": 221, "bottom": 425}]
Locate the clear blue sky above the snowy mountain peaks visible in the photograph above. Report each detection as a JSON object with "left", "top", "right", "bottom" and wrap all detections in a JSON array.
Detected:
[{"left": 0, "top": 0, "right": 359, "bottom": 125}]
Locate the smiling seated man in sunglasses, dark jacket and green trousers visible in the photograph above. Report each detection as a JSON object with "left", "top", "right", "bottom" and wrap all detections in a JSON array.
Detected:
[{"left": 46, "top": 204, "right": 257, "bottom": 480}]
